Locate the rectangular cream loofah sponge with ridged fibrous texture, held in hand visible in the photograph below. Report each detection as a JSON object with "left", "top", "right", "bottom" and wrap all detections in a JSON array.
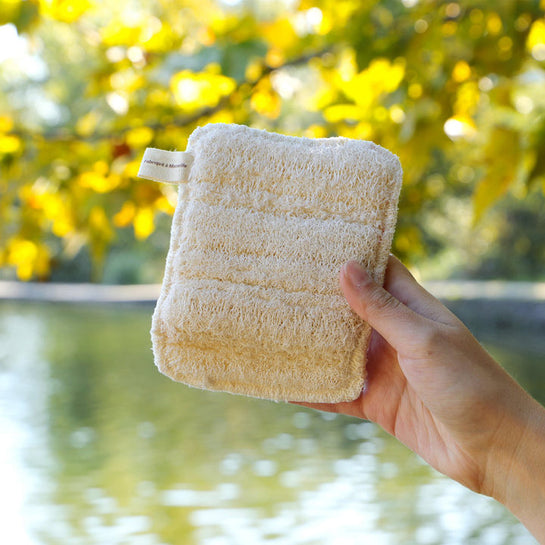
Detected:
[{"left": 148, "top": 124, "right": 402, "bottom": 402}]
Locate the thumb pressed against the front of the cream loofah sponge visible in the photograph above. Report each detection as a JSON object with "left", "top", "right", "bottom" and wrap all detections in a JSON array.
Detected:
[{"left": 340, "top": 261, "right": 431, "bottom": 352}]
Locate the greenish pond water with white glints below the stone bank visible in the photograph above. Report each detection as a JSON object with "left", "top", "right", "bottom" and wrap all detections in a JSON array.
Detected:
[{"left": 0, "top": 303, "right": 545, "bottom": 545}]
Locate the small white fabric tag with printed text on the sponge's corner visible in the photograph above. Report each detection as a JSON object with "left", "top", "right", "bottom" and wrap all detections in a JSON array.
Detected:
[{"left": 138, "top": 148, "right": 193, "bottom": 184}]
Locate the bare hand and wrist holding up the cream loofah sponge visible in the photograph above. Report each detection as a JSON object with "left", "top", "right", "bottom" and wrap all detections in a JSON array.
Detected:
[{"left": 303, "top": 256, "right": 545, "bottom": 542}]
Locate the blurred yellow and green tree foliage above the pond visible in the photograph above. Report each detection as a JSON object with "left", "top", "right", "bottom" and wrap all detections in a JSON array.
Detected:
[{"left": 0, "top": 0, "right": 545, "bottom": 280}]
